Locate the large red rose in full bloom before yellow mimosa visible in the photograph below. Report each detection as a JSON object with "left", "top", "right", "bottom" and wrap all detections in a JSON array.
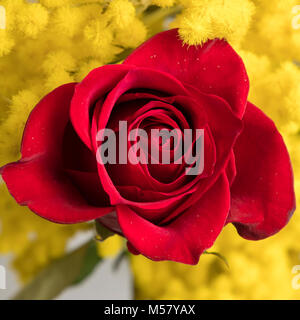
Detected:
[{"left": 2, "top": 30, "right": 295, "bottom": 264}]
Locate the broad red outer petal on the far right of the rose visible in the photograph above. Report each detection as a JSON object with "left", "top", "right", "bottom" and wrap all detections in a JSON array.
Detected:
[{"left": 228, "top": 103, "right": 295, "bottom": 240}]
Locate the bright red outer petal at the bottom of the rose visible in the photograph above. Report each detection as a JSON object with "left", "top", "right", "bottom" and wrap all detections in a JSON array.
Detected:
[{"left": 116, "top": 174, "right": 230, "bottom": 264}]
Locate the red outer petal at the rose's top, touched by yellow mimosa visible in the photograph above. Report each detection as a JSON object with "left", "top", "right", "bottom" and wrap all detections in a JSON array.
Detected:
[{"left": 124, "top": 29, "right": 249, "bottom": 118}]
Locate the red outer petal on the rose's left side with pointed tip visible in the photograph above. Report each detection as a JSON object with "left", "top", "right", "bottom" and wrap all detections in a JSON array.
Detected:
[{"left": 1, "top": 83, "right": 112, "bottom": 223}]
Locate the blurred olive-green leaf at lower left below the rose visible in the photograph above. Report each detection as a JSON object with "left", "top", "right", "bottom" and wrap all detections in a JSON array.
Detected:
[{"left": 13, "top": 240, "right": 100, "bottom": 300}]
